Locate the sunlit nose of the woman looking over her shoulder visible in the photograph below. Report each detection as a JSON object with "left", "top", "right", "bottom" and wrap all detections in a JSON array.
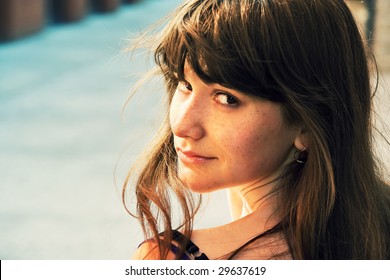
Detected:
[{"left": 169, "top": 93, "right": 206, "bottom": 140}]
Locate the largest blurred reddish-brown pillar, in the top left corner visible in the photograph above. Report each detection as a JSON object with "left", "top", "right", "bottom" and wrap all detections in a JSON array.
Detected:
[{"left": 0, "top": 0, "right": 46, "bottom": 41}]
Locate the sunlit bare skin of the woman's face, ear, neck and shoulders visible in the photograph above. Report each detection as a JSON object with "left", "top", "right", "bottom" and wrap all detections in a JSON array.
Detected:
[{"left": 135, "top": 65, "right": 305, "bottom": 259}]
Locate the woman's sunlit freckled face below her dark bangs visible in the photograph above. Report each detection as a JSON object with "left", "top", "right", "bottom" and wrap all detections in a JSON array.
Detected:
[{"left": 170, "top": 65, "right": 300, "bottom": 193}]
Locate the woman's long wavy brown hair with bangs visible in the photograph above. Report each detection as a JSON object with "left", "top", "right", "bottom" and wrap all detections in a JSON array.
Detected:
[{"left": 123, "top": 0, "right": 390, "bottom": 259}]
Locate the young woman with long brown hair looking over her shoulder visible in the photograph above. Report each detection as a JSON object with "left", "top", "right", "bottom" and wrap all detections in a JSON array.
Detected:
[{"left": 123, "top": 0, "right": 390, "bottom": 259}]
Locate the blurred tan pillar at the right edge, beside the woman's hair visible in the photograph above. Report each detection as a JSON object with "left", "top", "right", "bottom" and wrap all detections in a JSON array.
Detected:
[{"left": 374, "top": 0, "right": 390, "bottom": 71}]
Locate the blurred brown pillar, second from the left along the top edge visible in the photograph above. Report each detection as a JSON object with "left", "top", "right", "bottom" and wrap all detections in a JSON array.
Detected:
[{"left": 50, "top": 0, "right": 88, "bottom": 22}]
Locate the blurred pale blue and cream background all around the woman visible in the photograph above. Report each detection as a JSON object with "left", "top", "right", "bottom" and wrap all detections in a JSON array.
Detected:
[{"left": 0, "top": 0, "right": 390, "bottom": 259}]
